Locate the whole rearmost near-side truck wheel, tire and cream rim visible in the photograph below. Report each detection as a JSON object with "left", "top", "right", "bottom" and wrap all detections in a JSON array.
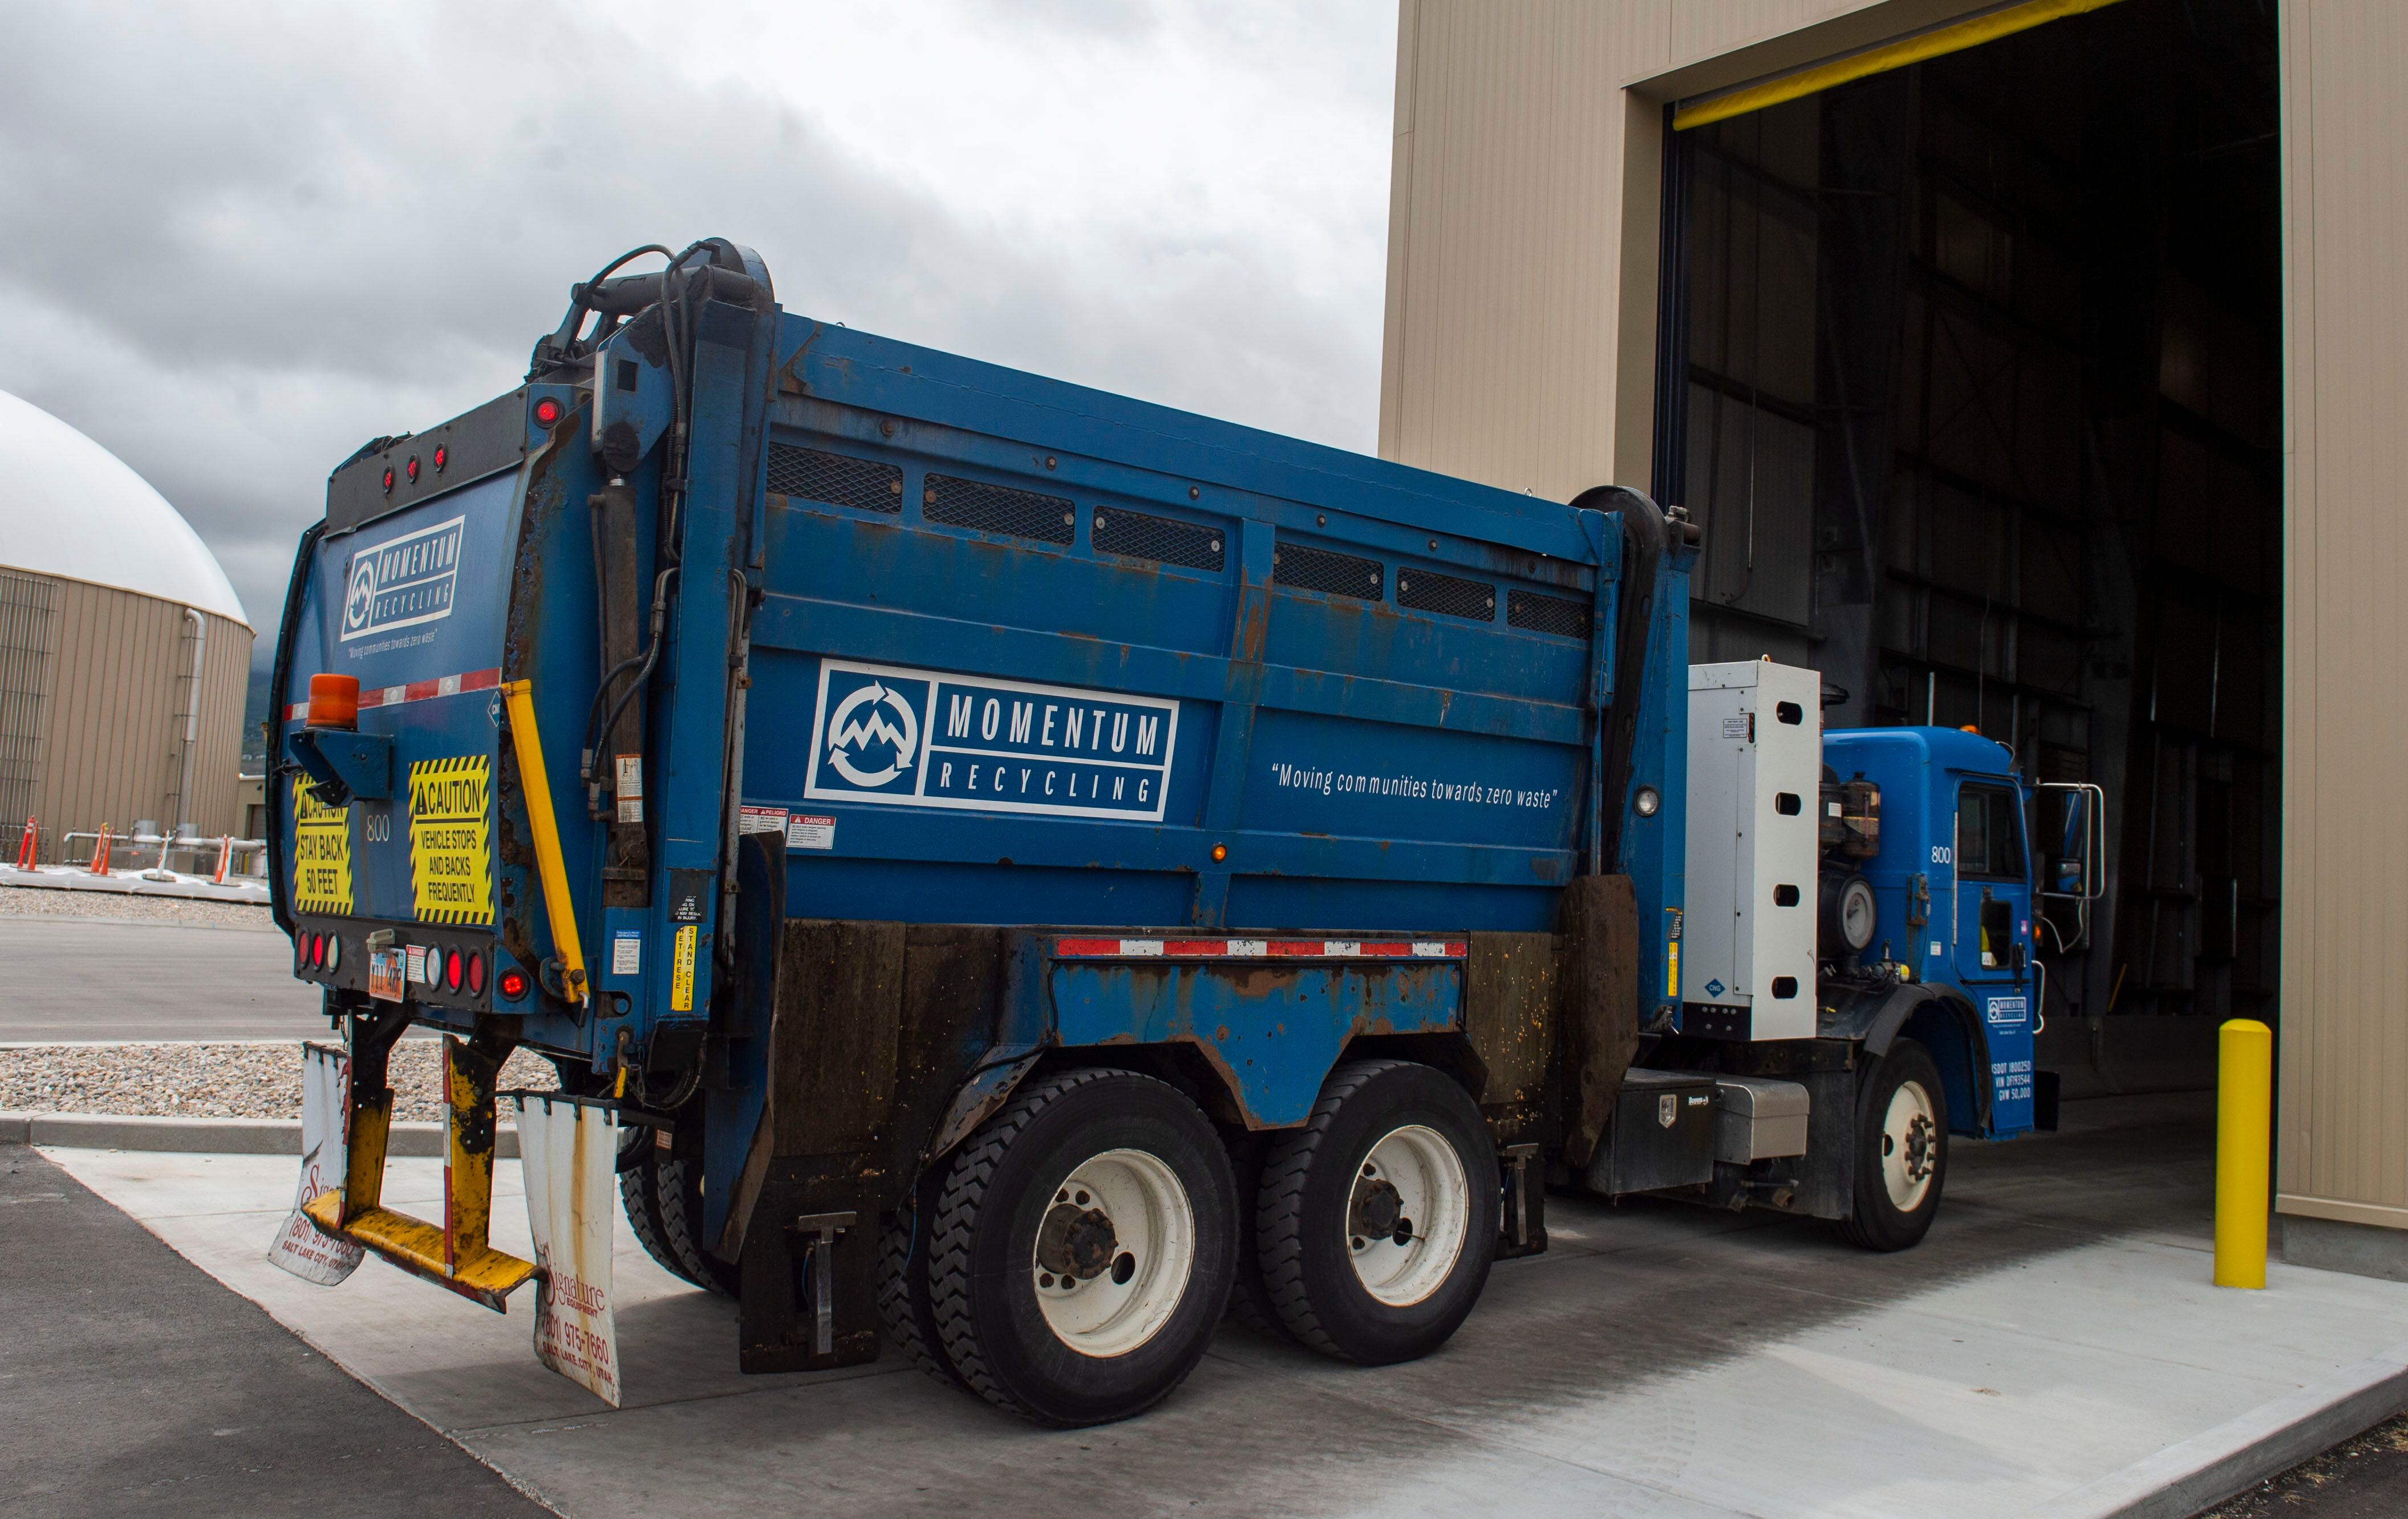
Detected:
[{"left": 927, "top": 1071, "right": 1238, "bottom": 1425}]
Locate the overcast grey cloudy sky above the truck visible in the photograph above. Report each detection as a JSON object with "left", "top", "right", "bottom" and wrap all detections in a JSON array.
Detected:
[{"left": 0, "top": 0, "right": 1397, "bottom": 655}]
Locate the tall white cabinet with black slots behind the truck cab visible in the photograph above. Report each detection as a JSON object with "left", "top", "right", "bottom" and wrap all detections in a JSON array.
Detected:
[{"left": 1681, "top": 659, "right": 1823, "bottom": 1040}]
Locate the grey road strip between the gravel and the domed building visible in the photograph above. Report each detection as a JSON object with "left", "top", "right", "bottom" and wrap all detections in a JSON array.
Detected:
[{"left": 0, "top": 917, "right": 325, "bottom": 1045}]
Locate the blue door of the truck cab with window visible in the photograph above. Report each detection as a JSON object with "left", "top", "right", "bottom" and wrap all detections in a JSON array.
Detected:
[{"left": 1955, "top": 777, "right": 2032, "bottom": 1134}]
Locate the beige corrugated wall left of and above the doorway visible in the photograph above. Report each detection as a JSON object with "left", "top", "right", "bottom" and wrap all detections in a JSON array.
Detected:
[{"left": 1380, "top": 0, "right": 1982, "bottom": 501}]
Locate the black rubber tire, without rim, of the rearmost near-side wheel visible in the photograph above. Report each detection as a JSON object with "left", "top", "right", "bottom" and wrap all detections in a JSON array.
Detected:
[{"left": 927, "top": 1071, "right": 1238, "bottom": 1428}]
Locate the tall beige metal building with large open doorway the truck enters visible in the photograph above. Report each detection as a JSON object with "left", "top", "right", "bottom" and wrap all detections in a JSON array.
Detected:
[{"left": 1380, "top": 0, "right": 2408, "bottom": 1276}]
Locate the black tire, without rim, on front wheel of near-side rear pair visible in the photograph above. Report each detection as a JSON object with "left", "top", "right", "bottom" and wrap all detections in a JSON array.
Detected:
[{"left": 1255, "top": 1059, "right": 1500, "bottom": 1365}]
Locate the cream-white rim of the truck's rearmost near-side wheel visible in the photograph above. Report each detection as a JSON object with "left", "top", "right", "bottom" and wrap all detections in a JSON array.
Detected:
[{"left": 1028, "top": 1151, "right": 1197, "bottom": 1358}]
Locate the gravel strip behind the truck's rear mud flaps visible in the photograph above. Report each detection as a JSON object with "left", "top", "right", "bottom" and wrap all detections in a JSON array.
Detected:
[{"left": 0, "top": 1040, "right": 559, "bottom": 1122}]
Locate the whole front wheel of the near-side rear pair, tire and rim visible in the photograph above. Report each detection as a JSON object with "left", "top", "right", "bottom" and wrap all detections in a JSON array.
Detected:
[{"left": 1255, "top": 1059, "right": 1500, "bottom": 1365}]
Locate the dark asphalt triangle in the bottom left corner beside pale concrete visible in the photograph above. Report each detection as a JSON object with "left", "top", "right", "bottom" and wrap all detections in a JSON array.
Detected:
[{"left": 0, "top": 1151, "right": 549, "bottom": 1519}]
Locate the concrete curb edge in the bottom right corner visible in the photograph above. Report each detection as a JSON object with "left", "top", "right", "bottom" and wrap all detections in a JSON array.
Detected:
[{"left": 2025, "top": 1343, "right": 2408, "bottom": 1519}]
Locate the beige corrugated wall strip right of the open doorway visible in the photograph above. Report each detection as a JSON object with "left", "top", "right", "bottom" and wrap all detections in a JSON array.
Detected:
[{"left": 2278, "top": 0, "right": 2408, "bottom": 1228}]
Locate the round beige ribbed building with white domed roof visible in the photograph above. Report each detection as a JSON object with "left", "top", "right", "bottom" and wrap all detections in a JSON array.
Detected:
[{"left": 0, "top": 392, "right": 253, "bottom": 862}]
